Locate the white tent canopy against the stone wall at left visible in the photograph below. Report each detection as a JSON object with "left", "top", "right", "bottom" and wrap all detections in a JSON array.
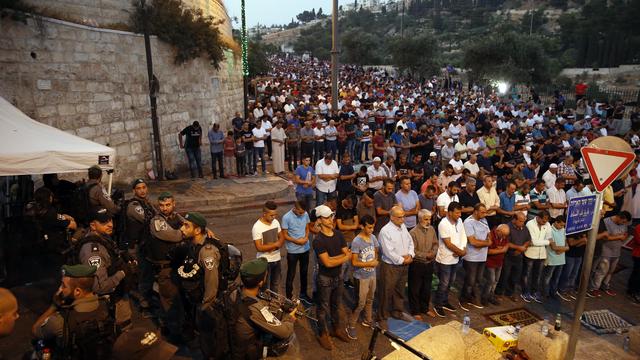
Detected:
[{"left": 0, "top": 97, "right": 116, "bottom": 176}]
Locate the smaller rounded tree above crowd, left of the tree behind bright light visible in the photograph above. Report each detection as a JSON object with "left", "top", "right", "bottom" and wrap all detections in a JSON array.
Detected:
[{"left": 389, "top": 34, "right": 439, "bottom": 77}]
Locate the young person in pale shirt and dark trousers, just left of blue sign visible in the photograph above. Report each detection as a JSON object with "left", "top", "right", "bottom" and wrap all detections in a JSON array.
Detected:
[{"left": 544, "top": 215, "right": 569, "bottom": 299}]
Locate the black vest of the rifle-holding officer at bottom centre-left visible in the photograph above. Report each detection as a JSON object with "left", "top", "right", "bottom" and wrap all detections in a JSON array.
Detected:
[{"left": 232, "top": 296, "right": 263, "bottom": 360}]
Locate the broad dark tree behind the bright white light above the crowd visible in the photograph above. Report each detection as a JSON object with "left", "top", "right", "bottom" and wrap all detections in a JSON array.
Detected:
[{"left": 464, "top": 31, "right": 553, "bottom": 84}]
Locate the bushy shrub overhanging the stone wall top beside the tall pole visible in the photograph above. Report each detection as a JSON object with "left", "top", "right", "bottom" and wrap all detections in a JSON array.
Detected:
[{"left": 131, "top": 0, "right": 226, "bottom": 69}]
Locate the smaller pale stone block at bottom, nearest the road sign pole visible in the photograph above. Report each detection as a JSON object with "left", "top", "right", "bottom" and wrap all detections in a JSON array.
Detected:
[{"left": 518, "top": 321, "right": 569, "bottom": 360}]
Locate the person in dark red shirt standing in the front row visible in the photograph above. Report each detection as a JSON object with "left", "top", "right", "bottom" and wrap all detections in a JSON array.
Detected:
[{"left": 481, "top": 224, "right": 508, "bottom": 306}]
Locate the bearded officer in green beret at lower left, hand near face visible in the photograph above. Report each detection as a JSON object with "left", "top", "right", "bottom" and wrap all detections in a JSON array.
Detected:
[{"left": 31, "top": 264, "right": 115, "bottom": 359}]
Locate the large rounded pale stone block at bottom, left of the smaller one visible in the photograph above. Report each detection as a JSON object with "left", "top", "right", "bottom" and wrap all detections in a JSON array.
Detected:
[{"left": 384, "top": 321, "right": 502, "bottom": 360}]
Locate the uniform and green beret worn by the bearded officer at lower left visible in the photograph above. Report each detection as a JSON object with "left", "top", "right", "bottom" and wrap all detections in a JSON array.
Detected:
[{"left": 35, "top": 264, "right": 115, "bottom": 359}]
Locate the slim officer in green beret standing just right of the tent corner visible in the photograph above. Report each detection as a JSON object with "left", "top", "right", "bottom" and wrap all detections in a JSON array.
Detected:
[{"left": 124, "top": 179, "right": 156, "bottom": 309}]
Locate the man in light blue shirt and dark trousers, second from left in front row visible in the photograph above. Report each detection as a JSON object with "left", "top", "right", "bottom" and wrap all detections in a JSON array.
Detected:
[{"left": 282, "top": 201, "right": 311, "bottom": 301}]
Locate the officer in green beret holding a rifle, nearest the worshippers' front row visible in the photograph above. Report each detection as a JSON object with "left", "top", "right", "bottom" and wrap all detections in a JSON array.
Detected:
[{"left": 233, "top": 258, "right": 296, "bottom": 360}]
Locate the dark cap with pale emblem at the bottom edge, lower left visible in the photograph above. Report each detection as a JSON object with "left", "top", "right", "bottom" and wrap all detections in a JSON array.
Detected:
[{"left": 111, "top": 327, "right": 178, "bottom": 360}]
